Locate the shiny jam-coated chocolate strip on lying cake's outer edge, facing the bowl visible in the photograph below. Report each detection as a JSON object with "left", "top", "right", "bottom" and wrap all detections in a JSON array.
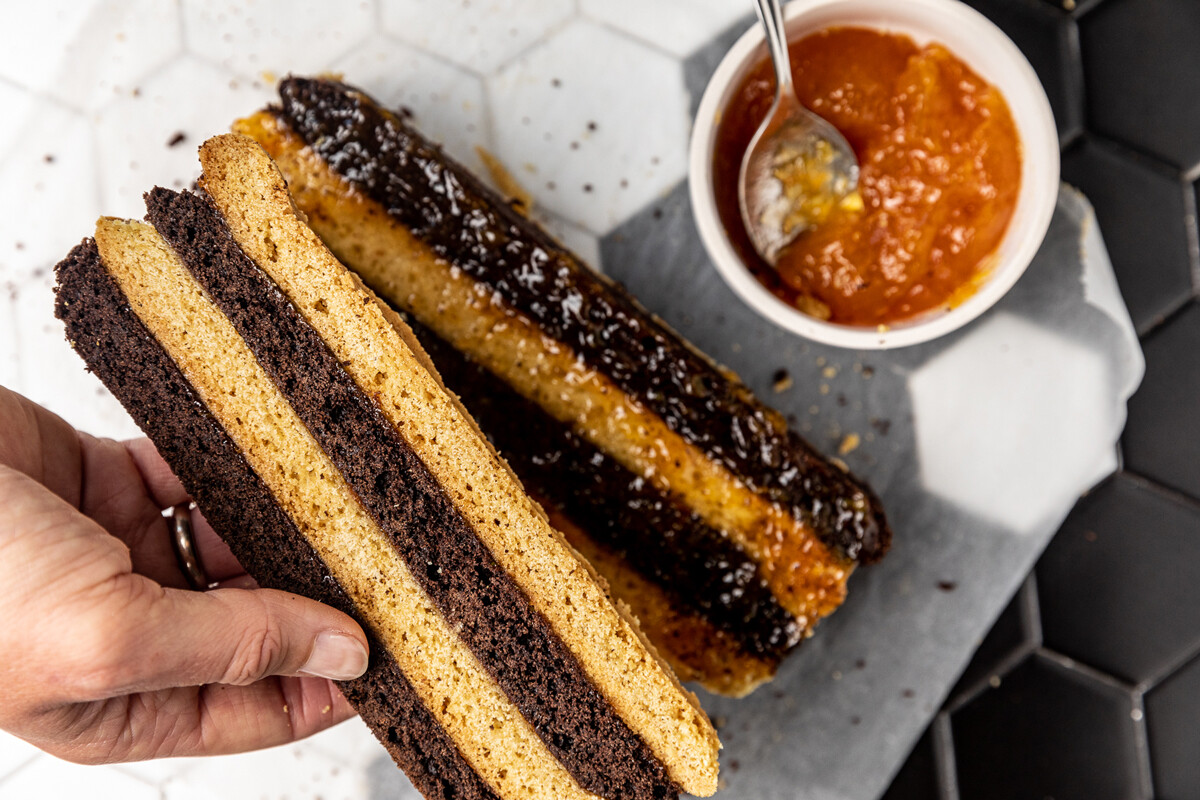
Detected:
[{"left": 272, "top": 78, "right": 892, "bottom": 563}]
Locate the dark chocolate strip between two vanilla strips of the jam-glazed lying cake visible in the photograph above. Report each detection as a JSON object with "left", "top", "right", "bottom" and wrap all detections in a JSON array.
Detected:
[{"left": 406, "top": 315, "right": 803, "bottom": 660}]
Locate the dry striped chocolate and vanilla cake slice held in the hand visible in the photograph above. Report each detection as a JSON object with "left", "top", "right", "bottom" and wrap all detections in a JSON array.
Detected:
[{"left": 56, "top": 134, "right": 719, "bottom": 800}]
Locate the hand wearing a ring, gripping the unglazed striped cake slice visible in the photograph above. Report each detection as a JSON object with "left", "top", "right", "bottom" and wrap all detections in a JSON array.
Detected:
[{"left": 0, "top": 387, "right": 367, "bottom": 764}]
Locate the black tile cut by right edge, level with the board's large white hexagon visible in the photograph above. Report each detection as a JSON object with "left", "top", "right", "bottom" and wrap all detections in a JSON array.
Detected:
[{"left": 1122, "top": 302, "right": 1200, "bottom": 498}]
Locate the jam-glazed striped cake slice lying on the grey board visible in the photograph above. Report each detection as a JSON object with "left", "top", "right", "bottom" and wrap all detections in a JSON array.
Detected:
[{"left": 235, "top": 78, "right": 890, "bottom": 694}]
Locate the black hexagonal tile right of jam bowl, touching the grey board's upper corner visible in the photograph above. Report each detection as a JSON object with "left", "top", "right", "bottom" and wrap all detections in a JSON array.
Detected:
[{"left": 1062, "top": 139, "right": 1200, "bottom": 333}]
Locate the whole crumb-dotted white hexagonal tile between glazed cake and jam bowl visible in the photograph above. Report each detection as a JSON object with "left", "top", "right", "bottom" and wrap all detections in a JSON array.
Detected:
[{"left": 487, "top": 22, "right": 689, "bottom": 234}]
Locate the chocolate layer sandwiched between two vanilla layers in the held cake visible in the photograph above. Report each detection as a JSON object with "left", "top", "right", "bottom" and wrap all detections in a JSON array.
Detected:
[{"left": 148, "top": 184, "right": 677, "bottom": 799}]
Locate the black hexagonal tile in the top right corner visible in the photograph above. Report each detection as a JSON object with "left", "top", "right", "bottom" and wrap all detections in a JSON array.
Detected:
[{"left": 1079, "top": 0, "right": 1200, "bottom": 169}]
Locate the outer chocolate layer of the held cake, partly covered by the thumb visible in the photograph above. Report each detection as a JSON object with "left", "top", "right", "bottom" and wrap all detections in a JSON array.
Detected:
[{"left": 55, "top": 239, "right": 499, "bottom": 800}]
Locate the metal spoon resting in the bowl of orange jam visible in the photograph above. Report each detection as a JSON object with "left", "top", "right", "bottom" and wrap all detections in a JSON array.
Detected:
[{"left": 738, "top": 0, "right": 862, "bottom": 266}]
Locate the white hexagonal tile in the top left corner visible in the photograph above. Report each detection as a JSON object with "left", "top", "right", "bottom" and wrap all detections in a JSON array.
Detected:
[{"left": 0, "top": 0, "right": 181, "bottom": 109}]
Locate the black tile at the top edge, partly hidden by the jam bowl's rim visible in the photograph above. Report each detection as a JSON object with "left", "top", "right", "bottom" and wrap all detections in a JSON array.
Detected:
[{"left": 965, "top": 0, "right": 1084, "bottom": 140}]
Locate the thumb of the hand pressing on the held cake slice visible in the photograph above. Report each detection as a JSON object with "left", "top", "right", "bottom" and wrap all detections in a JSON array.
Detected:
[{"left": 71, "top": 576, "right": 367, "bottom": 702}]
